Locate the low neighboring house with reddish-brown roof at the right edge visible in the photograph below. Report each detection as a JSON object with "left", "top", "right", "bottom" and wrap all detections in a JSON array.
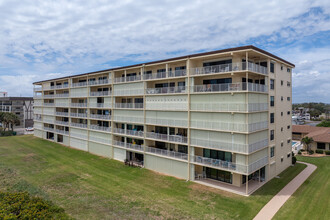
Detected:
[{"left": 292, "top": 125, "right": 330, "bottom": 150}]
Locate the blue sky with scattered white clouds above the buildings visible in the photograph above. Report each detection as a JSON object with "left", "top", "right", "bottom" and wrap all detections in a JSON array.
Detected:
[{"left": 0, "top": 0, "right": 330, "bottom": 103}]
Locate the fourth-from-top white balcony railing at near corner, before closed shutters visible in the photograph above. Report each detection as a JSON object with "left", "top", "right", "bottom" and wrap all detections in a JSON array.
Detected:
[{"left": 190, "top": 120, "right": 268, "bottom": 132}]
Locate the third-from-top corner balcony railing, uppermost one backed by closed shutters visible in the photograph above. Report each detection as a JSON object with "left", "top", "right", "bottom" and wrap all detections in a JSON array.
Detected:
[{"left": 191, "top": 102, "right": 268, "bottom": 112}]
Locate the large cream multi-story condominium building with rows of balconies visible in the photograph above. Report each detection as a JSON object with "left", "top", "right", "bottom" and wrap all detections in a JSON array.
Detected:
[{"left": 34, "top": 46, "right": 294, "bottom": 194}]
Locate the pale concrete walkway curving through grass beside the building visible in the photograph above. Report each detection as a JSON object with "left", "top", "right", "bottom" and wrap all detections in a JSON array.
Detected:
[{"left": 254, "top": 162, "right": 317, "bottom": 220}]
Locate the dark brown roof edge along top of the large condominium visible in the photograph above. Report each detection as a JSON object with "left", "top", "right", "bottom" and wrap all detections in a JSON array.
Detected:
[{"left": 33, "top": 45, "right": 295, "bottom": 84}]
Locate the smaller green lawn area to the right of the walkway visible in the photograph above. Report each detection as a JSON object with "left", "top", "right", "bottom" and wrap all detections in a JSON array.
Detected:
[{"left": 275, "top": 156, "right": 330, "bottom": 219}]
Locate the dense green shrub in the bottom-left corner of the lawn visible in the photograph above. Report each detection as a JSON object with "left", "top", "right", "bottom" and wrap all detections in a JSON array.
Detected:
[{"left": 0, "top": 192, "right": 69, "bottom": 219}]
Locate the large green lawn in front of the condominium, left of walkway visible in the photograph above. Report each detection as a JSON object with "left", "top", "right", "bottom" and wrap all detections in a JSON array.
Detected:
[{"left": 0, "top": 135, "right": 306, "bottom": 219}]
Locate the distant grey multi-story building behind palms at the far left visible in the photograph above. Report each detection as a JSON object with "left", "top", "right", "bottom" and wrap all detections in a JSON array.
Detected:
[{"left": 0, "top": 96, "right": 33, "bottom": 128}]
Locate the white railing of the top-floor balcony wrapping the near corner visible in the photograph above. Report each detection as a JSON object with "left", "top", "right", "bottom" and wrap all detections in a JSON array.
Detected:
[{"left": 190, "top": 62, "right": 268, "bottom": 76}]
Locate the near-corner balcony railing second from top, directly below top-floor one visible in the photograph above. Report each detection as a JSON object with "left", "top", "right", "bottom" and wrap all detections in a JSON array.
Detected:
[{"left": 192, "top": 82, "right": 268, "bottom": 93}]
